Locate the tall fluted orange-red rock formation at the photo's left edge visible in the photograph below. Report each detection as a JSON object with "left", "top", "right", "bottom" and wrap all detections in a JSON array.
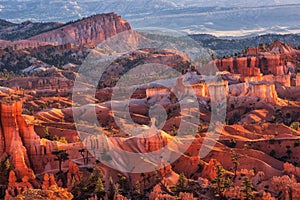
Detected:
[{"left": 0, "top": 102, "right": 62, "bottom": 196}]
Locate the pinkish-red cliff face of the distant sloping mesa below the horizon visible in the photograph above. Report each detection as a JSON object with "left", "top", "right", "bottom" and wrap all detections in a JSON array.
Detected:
[{"left": 30, "top": 13, "right": 131, "bottom": 46}]
